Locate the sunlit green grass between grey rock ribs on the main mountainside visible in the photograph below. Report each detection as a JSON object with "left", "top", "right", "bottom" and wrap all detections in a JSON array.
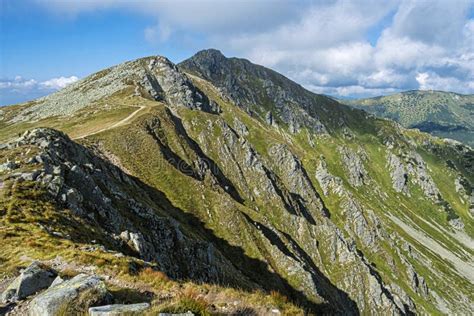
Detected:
[{"left": 0, "top": 77, "right": 474, "bottom": 313}]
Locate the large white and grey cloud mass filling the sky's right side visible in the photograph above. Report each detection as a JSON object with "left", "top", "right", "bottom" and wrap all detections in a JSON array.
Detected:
[{"left": 25, "top": 0, "right": 474, "bottom": 95}]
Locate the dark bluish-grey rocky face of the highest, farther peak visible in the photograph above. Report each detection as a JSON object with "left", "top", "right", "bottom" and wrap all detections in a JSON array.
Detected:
[{"left": 178, "top": 49, "right": 328, "bottom": 134}]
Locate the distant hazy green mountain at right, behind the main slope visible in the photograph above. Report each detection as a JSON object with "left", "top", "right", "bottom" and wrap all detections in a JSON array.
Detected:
[{"left": 342, "top": 90, "right": 474, "bottom": 147}]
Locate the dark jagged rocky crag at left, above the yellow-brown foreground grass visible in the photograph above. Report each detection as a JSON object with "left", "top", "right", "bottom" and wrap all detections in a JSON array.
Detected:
[{"left": 12, "top": 129, "right": 245, "bottom": 282}]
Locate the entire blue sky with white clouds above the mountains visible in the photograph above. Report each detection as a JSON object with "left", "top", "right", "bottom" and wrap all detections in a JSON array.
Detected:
[{"left": 0, "top": 0, "right": 474, "bottom": 105}]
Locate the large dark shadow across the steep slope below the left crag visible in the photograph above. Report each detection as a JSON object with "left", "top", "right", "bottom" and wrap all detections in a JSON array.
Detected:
[{"left": 41, "top": 134, "right": 359, "bottom": 314}]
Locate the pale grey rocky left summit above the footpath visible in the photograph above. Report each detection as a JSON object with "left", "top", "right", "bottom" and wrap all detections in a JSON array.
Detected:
[{"left": 12, "top": 56, "right": 220, "bottom": 122}]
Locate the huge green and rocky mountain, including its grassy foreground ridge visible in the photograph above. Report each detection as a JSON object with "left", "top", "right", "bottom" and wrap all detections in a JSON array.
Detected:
[{"left": 0, "top": 49, "right": 474, "bottom": 315}]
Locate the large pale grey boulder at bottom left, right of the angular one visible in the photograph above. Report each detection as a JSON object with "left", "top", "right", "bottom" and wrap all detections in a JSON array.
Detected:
[{"left": 29, "top": 274, "right": 110, "bottom": 316}]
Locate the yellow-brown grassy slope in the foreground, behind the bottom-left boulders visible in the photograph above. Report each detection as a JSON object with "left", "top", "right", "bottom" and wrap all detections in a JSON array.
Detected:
[{"left": 0, "top": 144, "right": 303, "bottom": 315}]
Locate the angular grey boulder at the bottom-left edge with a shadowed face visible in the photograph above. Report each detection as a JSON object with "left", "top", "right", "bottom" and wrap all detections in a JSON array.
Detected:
[{"left": 0, "top": 262, "right": 56, "bottom": 303}]
